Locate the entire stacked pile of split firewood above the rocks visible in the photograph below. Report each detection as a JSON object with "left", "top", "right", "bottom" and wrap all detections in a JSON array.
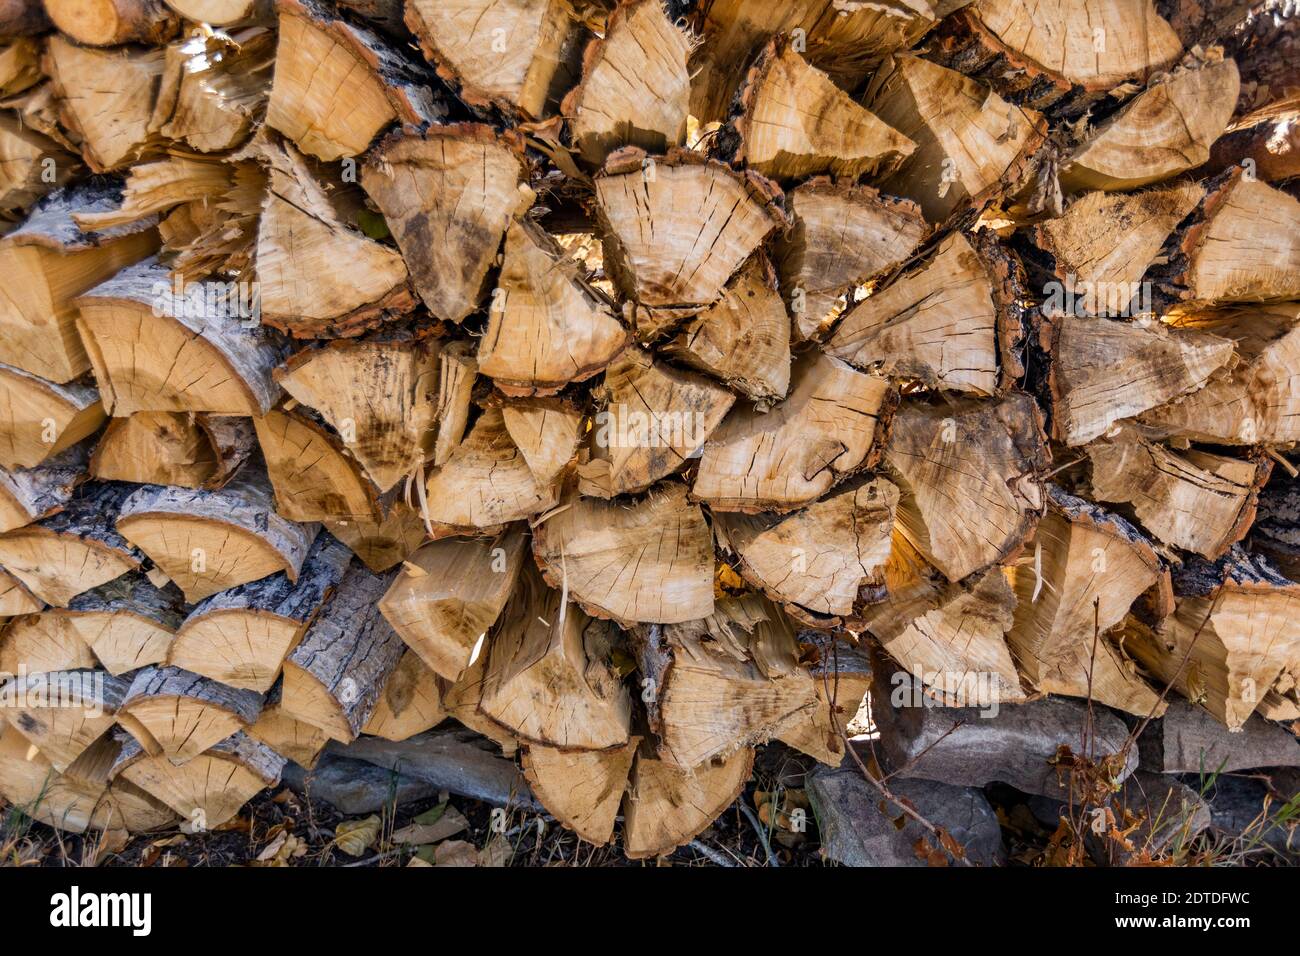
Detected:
[{"left": 0, "top": 0, "right": 1300, "bottom": 857}]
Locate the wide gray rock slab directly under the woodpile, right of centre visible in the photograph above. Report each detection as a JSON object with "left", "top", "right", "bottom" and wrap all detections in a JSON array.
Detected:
[{"left": 871, "top": 672, "right": 1138, "bottom": 799}]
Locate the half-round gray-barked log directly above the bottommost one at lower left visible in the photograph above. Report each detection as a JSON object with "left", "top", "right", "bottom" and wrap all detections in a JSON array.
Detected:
[{"left": 117, "top": 666, "right": 261, "bottom": 766}]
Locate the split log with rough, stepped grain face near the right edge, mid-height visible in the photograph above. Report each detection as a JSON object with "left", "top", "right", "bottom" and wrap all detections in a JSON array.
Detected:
[{"left": 1086, "top": 428, "right": 1273, "bottom": 561}]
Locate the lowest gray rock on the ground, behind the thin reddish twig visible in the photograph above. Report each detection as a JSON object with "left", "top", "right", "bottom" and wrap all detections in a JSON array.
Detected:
[{"left": 807, "top": 766, "right": 1006, "bottom": 866}]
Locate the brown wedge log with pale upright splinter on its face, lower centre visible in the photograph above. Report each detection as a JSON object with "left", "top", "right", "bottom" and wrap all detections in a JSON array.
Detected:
[{"left": 478, "top": 567, "right": 632, "bottom": 750}]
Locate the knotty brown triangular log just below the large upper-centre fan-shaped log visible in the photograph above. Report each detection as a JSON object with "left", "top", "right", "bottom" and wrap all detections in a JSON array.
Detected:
[{"left": 663, "top": 252, "right": 790, "bottom": 402}]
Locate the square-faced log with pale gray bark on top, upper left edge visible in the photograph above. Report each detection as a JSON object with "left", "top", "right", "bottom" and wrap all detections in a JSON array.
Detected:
[{"left": 0, "top": 185, "right": 159, "bottom": 382}]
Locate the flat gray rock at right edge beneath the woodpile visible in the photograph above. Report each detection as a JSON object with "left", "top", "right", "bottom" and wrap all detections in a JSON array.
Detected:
[{"left": 1138, "top": 700, "right": 1300, "bottom": 774}]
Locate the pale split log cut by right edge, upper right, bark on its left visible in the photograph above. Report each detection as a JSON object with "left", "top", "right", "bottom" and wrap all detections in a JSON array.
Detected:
[{"left": 1174, "top": 168, "right": 1300, "bottom": 303}]
